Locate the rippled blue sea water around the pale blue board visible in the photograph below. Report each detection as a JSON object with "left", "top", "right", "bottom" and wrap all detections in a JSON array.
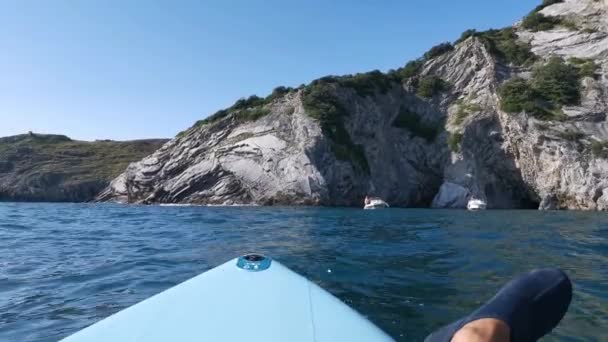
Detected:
[{"left": 0, "top": 203, "right": 608, "bottom": 341}]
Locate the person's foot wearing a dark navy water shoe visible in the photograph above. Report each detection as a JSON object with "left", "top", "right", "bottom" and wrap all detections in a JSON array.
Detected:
[{"left": 425, "top": 269, "right": 572, "bottom": 342}]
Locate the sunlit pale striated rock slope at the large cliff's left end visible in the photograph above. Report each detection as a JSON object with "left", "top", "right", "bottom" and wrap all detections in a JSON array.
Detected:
[{"left": 98, "top": 96, "right": 327, "bottom": 205}]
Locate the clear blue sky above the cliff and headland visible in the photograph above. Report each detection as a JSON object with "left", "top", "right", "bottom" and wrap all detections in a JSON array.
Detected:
[{"left": 0, "top": 0, "right": 540, "bottom": 140}]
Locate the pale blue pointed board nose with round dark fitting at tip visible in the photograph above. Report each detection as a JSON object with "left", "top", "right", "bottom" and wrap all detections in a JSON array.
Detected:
[{"left": 63, "top": 254, "right": 394, "bottom": 342}]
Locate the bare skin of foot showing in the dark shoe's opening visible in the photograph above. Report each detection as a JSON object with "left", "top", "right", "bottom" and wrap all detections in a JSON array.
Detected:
[{"left": 452, "top": 318, "right": 510, "bottom": 342}]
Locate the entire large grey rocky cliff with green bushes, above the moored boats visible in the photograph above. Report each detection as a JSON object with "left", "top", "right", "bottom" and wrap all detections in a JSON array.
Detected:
[{"left": 98, "top": 0, "right": 608, "bottom": 210}]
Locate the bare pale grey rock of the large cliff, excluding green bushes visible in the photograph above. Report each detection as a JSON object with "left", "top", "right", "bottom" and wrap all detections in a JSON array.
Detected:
[{"left": 98, "top": 0, "right": 608, "bottom": 210}]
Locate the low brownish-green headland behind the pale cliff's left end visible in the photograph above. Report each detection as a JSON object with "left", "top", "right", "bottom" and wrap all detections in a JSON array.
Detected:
[{"left": 0, "top": 133, "right": 166, "bottom": 202}]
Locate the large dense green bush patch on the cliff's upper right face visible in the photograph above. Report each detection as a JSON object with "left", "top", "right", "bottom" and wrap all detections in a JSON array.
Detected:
[{"left": 500, "top": 57, "right": 580, "bottom": 120}]
